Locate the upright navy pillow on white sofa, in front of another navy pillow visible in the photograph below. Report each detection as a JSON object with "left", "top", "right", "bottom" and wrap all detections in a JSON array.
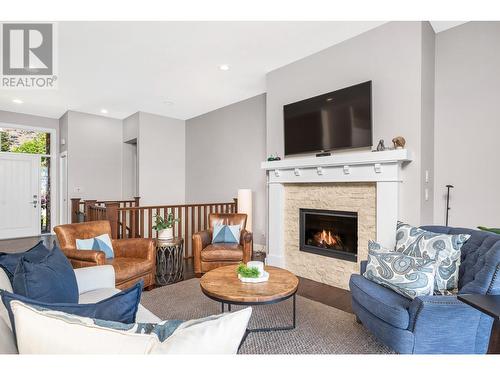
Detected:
[{"left": 12, "top": 242, "right": 79, "bottom": 303}]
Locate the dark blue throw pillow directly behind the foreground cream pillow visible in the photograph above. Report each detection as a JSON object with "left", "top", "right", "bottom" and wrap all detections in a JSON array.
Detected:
[{"left": 0, "top": 281, "right": 144, "bottom": 342}]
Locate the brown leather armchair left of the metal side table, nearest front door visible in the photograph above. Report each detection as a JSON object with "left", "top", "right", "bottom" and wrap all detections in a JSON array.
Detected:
[{"left": 54, "top": 221, "right": 156, "bottom": 289}]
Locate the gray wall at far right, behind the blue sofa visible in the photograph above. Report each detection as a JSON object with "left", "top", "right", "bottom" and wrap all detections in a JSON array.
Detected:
[{"left": 434, "top": 22, "right": 500, "bottom": 227}]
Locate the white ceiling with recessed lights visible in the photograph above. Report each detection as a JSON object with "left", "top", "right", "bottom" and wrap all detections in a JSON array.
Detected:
[{"left": 0, "top": 21, "right": 464, "bottom": 119}]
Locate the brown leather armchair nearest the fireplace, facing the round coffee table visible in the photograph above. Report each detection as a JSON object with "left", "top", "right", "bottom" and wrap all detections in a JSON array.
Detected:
[{"left": 193, "top": 214, "right": 253, "bottom": 275}]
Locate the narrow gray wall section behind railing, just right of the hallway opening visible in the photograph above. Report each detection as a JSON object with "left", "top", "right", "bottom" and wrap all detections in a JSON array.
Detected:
[{"left": 137, "top": 112, "right": 186, "bottom": 205}]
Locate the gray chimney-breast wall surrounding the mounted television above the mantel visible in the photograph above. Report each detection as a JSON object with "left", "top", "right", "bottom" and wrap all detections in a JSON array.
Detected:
[{"left": 267, "top": 22, "right": 425, "bottom": 224}]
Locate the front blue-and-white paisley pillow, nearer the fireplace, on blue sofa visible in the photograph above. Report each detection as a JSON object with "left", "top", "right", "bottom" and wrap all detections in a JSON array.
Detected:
[{"left": 363, "top": 241, "right": 436, "bottom": 299}]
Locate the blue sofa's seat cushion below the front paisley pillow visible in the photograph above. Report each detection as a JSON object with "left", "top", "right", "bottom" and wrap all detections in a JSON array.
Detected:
[{"left": 349, "top": 275, "right": 411, "bottom": 329}]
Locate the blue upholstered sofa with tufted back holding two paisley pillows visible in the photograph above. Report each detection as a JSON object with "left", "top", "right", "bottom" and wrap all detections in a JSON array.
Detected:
[{"left": 349, "top": 226, "right": 500, "bottom": 354}]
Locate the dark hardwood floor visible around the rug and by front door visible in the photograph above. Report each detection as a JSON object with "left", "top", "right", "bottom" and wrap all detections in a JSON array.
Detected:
[{"left": 0, "top": 235, "right": 352, "bottom": 313}]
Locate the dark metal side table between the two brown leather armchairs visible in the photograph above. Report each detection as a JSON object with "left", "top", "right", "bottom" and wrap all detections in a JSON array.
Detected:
[{"left": 156, "top": 237, "right": 184, "bottom": 285}]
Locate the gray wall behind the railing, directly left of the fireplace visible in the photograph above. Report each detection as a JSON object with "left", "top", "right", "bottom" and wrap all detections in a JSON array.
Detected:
[{"left": 186, "top": 94, "right": 267, "bottom": 244}]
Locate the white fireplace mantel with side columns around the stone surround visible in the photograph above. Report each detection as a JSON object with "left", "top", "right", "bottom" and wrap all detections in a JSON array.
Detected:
[{"left": 261, "top": 149, "right": 411, "bottom": 268}]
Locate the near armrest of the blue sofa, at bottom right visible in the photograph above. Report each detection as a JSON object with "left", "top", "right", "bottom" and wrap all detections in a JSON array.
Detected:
[{"left": 408, "top": 296, "right": 493, "bottom": 354}]
